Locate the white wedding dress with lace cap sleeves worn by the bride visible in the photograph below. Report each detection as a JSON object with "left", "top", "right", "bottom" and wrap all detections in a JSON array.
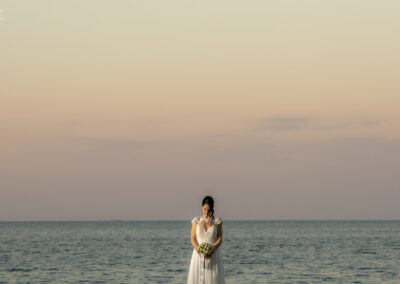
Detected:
[{"left": 187, "top": 217, "right": 225, "bottom": 284}]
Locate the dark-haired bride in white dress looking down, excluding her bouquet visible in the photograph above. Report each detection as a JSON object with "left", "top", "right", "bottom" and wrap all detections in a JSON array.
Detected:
[{"left": 187, "top": 196, "right": 225, "bottom": 284}]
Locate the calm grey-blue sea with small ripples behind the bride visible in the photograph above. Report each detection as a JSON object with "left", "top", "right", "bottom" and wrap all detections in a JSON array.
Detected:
[{"left": 0, "top": 220, "right": 400, "bottom": 283}]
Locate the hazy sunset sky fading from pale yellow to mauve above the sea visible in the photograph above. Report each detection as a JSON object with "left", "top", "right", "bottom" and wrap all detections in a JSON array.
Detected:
[{"left": 0, "top": 0, "right": 400, "bottom": 221}]
